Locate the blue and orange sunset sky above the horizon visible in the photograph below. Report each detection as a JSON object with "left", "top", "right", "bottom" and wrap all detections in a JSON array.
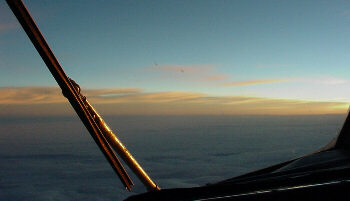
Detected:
[{"left": 0, "top": 0, "right": 350, "bottom": 116}]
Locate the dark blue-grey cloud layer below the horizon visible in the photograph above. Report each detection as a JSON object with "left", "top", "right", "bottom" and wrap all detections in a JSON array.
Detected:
[{"left": 0, "top": 115, "right": 344, "bottom": 201}]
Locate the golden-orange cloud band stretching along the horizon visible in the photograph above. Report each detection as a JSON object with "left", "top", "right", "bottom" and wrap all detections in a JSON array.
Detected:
[{"left": 0, "top": 87, "right": 348, "bottom": 116}]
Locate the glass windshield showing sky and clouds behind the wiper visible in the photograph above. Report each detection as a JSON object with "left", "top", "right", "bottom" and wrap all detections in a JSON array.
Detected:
[{"left": 0, "top": 1, "right": 350, "bottom": 200}]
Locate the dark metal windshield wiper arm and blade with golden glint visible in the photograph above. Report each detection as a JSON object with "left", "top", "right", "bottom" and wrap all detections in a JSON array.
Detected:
[{"left": 6, "top": 0, "right": 159, "bottom": 190}]
